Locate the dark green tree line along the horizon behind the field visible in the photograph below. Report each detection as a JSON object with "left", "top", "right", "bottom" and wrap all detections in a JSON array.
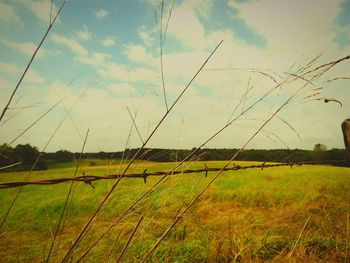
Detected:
[{"left": 0, "top": 144, "right": 347, "bottom": 171}]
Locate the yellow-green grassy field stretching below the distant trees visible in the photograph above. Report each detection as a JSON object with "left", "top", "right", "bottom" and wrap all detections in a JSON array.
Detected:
[{"left": 0, "top": 162, "right": 350, "bottom": 262}]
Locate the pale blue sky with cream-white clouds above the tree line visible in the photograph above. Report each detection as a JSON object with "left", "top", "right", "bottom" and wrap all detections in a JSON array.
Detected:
[{"left": 0, "top": 0, "right": 350, "bottom": 152}]
